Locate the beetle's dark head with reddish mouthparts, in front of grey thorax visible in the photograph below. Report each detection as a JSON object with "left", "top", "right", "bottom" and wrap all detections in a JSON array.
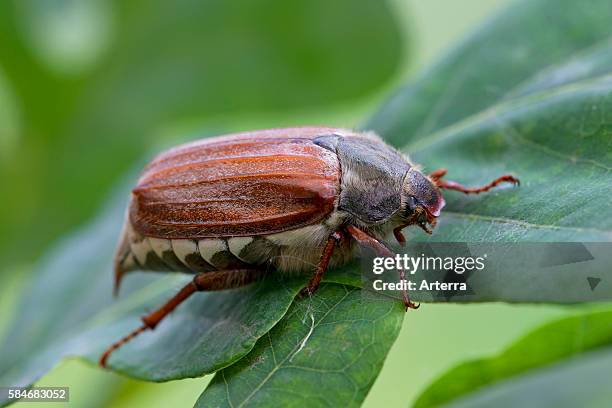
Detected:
[{"left": 394, "top": 168, "right": 445, "bottom": 243}]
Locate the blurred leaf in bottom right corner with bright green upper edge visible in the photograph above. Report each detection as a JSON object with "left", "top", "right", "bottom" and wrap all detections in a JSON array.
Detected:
[{"left": 415, "top": 309, "right": 612, "bottom": 407}]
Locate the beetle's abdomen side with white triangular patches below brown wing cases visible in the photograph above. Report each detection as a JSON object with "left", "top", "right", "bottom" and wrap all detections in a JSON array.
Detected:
[{"left": 115, "top": 212, "right": 351, "bottom": 286}]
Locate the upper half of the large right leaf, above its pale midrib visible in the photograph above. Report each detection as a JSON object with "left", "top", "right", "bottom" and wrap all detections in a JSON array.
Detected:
[{"left": 365, "top": 0, "right": 612, "bottom": 146}]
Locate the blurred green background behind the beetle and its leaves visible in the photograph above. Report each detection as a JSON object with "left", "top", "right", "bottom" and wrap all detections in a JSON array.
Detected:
[{"left": 0, "top": 0, "right": 563, "bottom": 407}]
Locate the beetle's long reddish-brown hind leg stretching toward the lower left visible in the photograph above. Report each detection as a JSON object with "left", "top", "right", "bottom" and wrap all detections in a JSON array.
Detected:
[{"left": 99, "top": 269, "right": 265, "bottom": 367}]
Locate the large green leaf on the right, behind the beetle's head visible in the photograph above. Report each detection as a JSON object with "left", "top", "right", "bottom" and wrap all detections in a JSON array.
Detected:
[{"left": 366, "top": 0, "right": 612, "bottom": 302}]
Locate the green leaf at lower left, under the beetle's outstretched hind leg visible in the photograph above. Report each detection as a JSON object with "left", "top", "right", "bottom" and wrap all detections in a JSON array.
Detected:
[{"left": 0, "top": 194, "right": 304, "bottom": 404}]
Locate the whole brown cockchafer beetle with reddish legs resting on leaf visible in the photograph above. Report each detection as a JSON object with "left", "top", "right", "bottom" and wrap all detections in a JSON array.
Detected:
[{"left": 100, "top": 127, "right": 518, "bottom": 366}]
